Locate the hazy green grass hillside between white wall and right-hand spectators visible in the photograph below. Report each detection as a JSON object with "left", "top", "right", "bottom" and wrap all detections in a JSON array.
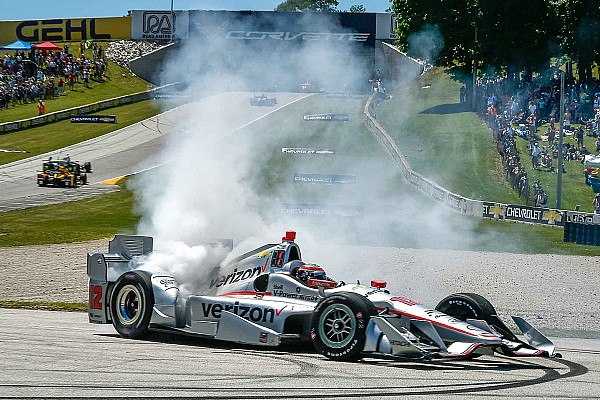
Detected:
[{"left": 377, "top": 69, "right": 522, "bottom": 204}]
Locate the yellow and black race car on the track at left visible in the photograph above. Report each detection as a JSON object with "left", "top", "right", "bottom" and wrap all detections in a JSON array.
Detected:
[{"left": 37, "top": 157, "right": 92, "bottom": 187}]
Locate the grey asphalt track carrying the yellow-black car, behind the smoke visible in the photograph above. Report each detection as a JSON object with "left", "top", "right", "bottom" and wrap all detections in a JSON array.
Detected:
[{"left": 0, "top": 92, "right": 307, "bottom": 212}]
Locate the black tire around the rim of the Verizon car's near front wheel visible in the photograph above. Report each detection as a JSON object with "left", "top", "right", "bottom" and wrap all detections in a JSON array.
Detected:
[{"left": 310, "top": 292, "right": 376, "bottom": 361}]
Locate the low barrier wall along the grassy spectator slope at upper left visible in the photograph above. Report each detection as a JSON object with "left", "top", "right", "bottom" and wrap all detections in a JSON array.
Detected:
[{"left": 0, "top": 83, "right": 177, "bottom": 135}]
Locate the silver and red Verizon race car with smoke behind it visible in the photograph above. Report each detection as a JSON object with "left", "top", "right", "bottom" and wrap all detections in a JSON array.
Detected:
[{"left": 87, "top": 231, "right": 560, "bottom": 361}]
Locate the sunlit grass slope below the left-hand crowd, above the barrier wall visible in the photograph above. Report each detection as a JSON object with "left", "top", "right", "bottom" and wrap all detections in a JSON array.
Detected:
[{"left": 0, "top": 46, "right": 154, "bottom": 123}]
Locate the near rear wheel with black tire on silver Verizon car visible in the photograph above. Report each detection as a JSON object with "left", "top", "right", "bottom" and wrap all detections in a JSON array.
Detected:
[{"left": 110, "top": 271, "right": 154, "bottom": 339}]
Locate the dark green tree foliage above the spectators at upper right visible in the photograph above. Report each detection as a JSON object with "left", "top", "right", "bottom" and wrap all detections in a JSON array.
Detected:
[{"left": 392, "top": 0, "right": 600, "bottom": 80}]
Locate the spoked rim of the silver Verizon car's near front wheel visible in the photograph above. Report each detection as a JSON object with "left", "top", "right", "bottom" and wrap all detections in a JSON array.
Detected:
[{"left": 319, "top": 304, "right": 356, "bottom": 348}]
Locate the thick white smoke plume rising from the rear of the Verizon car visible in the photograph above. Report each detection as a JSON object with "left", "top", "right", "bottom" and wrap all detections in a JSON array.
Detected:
[{"left": 131, "top": 11, "right": 368, "bottom": 283}]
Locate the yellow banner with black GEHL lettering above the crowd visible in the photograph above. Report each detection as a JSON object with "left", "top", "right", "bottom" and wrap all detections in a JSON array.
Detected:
[{"left": 0, "top": 17, "right": 131, "bottom": 46}]
